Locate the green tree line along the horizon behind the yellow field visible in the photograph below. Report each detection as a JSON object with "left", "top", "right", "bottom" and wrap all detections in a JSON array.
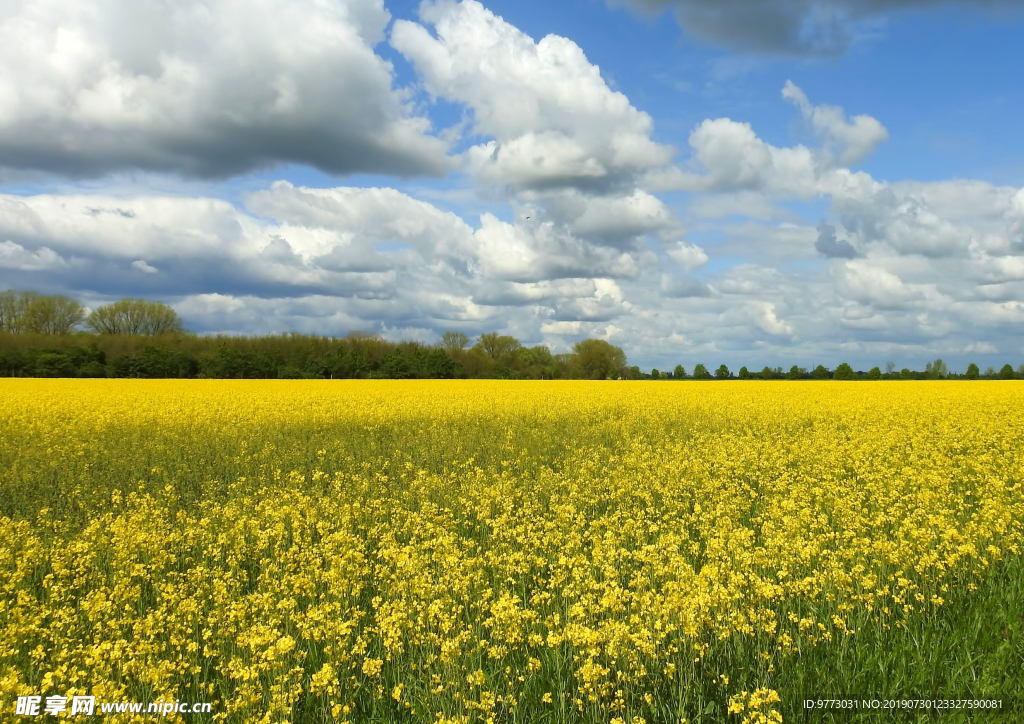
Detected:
[{"left": 0, "top": 290, "right": 1024, "bottom": 380}]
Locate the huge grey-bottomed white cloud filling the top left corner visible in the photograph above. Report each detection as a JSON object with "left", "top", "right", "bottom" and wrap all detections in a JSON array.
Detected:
[{"left": 0, "top": 0, "right": 451, "bottom": 177}]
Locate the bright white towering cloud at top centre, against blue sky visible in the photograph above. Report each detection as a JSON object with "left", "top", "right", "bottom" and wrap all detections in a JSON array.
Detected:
[{"left": 391, "top": 0, "right": 673, "bottom": 190}]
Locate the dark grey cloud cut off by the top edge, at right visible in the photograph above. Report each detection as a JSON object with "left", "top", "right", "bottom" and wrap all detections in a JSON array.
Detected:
[{"left": 607, "top": 0, "right": 1024, "bottom": 55}]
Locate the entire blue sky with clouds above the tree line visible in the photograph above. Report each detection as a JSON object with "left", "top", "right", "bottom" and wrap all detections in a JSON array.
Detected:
[{"left": 0, "top": 0, "right": 1024, "bottom": 371}]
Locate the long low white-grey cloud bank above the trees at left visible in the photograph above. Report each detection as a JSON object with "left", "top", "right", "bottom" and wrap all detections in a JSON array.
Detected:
[{"left": 0, "top": 182, "right": 650, "bottom": 325}]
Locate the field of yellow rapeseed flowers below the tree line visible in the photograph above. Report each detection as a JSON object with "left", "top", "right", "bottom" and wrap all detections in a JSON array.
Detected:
[{"left": 0, "top": 380, "right": 1024, "bottom": 724}]
